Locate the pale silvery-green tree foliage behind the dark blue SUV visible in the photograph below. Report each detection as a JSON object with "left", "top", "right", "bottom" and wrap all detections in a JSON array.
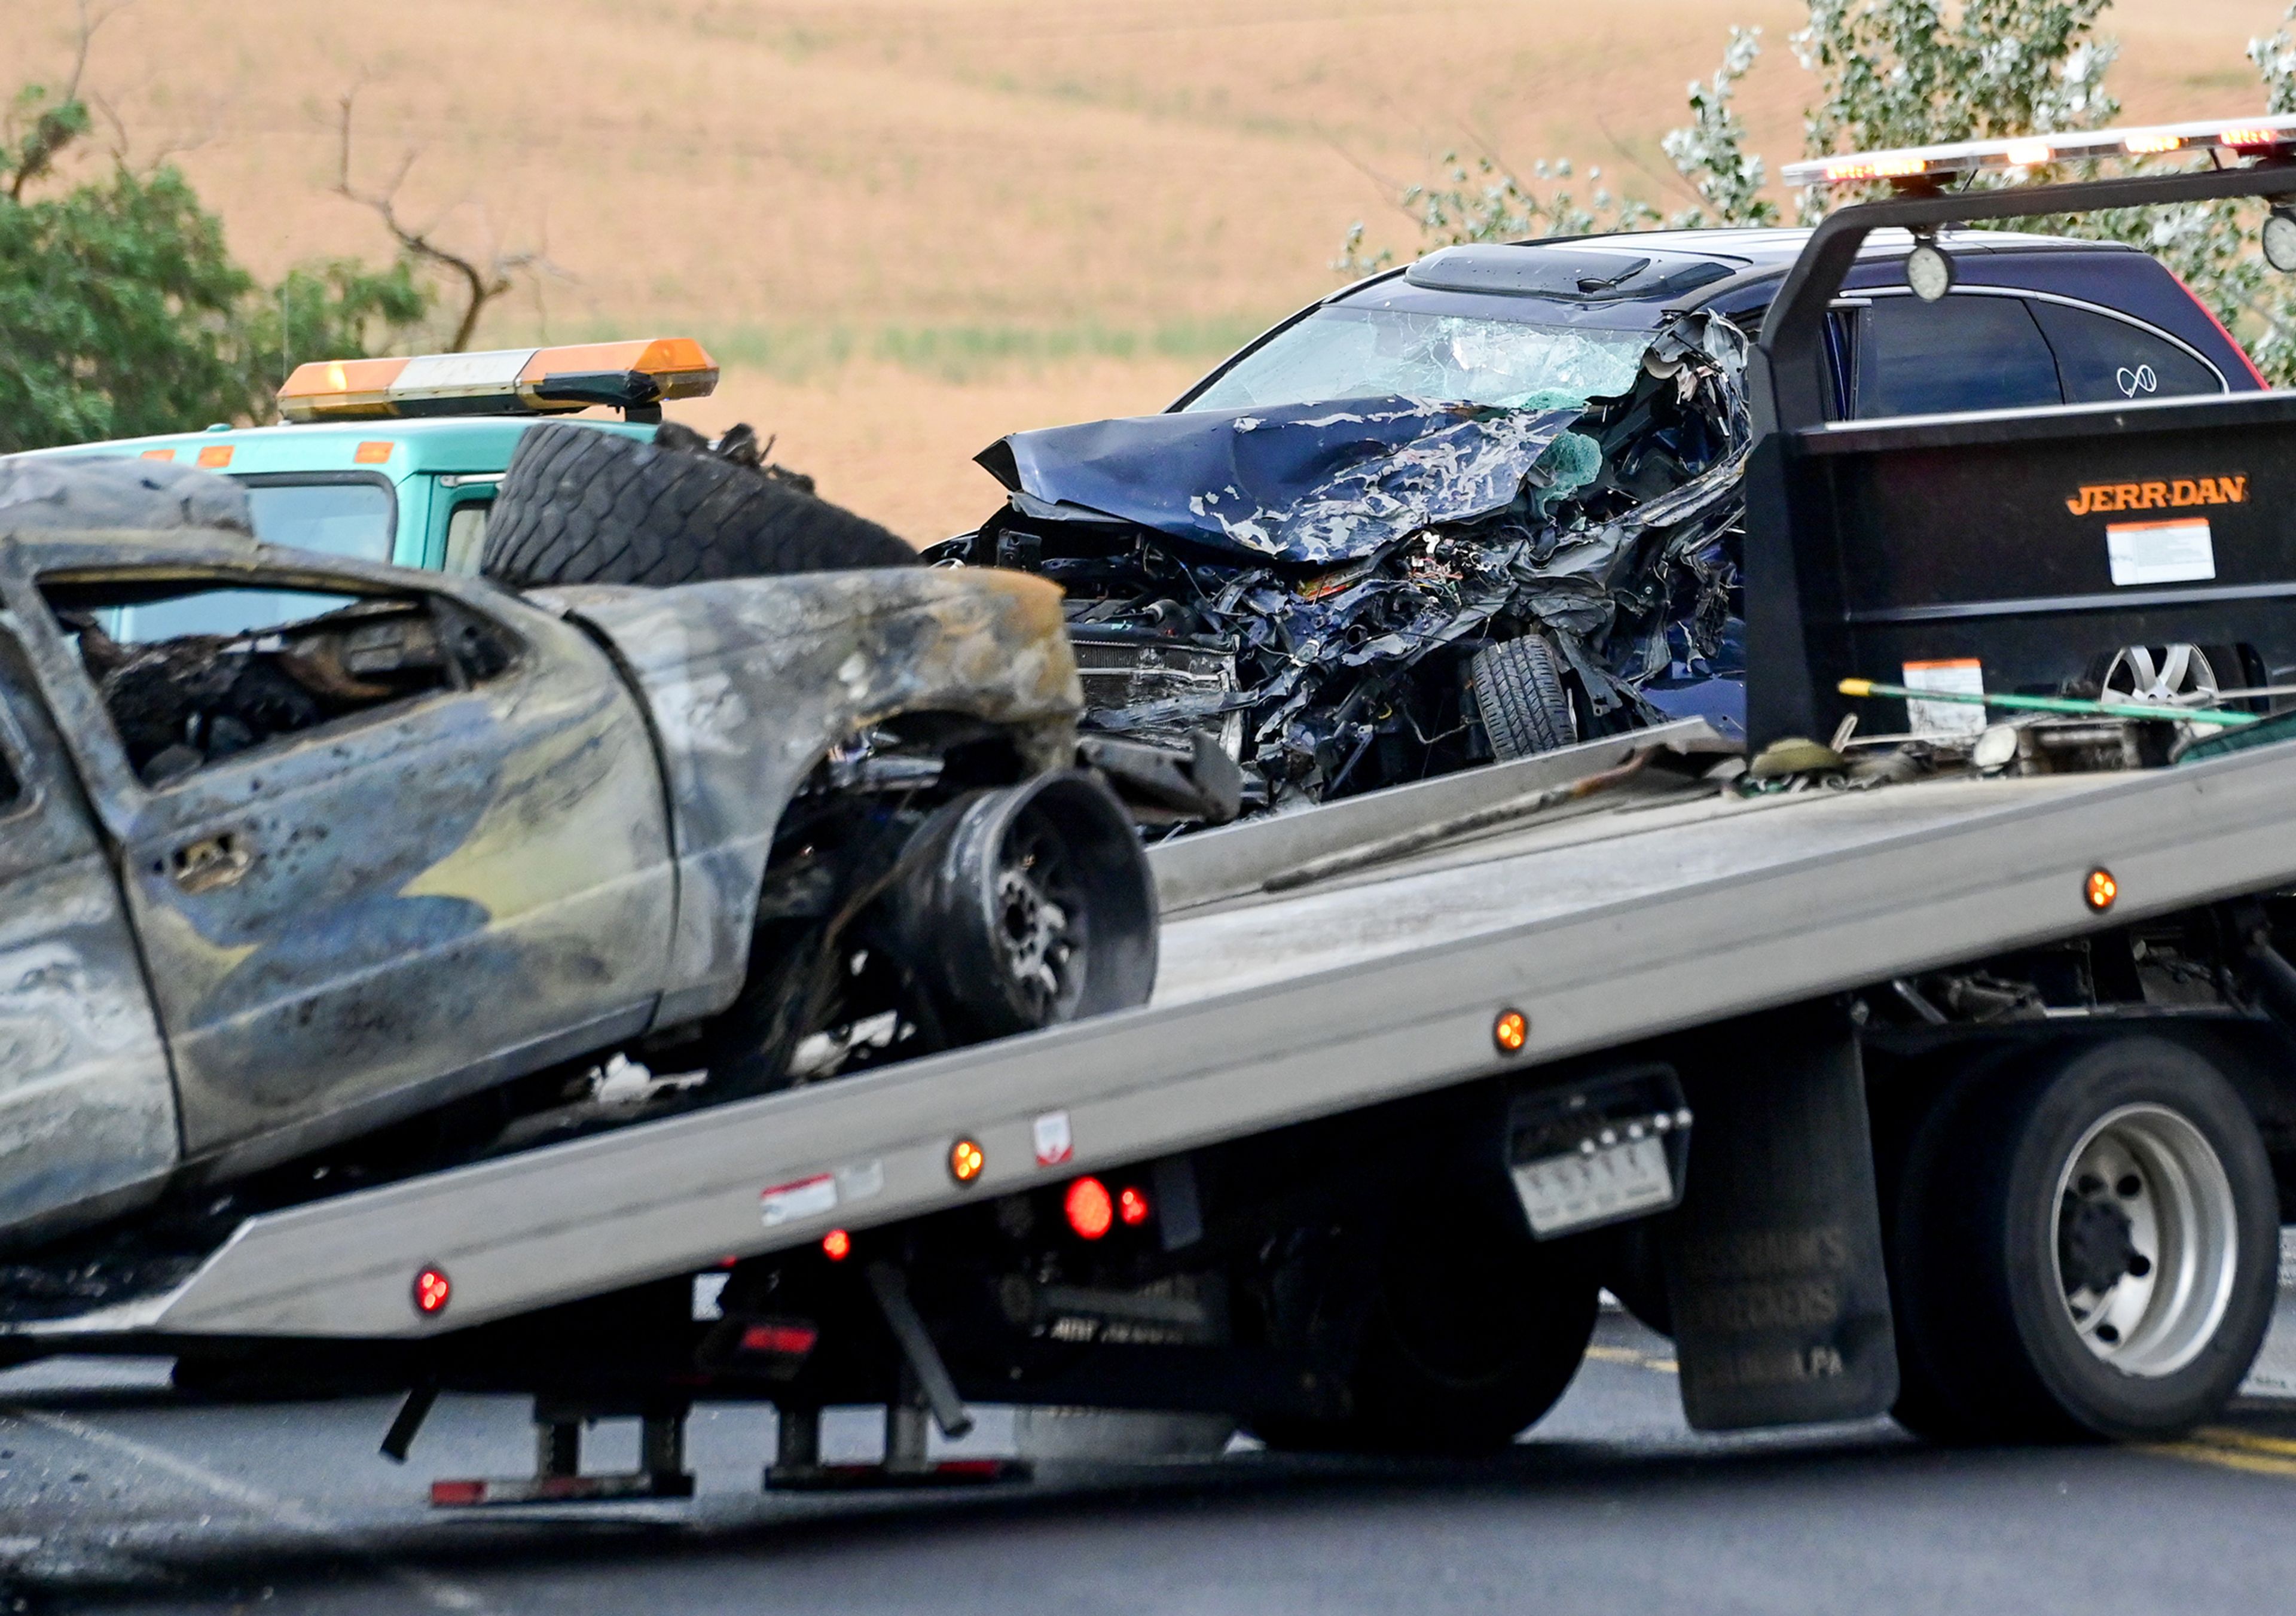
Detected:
[{"left": 1334, "top": 0, "right": 2296, "bottom": 386}]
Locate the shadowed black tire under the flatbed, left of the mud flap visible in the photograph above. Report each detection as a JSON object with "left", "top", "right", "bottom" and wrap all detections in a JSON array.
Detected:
[{"left": 1254, "top": 1200, "right": 1600, "bottom": 1455}]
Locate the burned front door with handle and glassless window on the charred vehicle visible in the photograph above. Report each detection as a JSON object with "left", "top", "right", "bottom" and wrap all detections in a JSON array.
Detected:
[{"left": 13, "top": 565, "right": 675, "bottom": 1169}]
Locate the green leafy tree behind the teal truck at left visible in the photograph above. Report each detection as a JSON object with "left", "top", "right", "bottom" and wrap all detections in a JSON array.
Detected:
[{"left": 0, "top": 85, "right": 432, "bottom": 452}]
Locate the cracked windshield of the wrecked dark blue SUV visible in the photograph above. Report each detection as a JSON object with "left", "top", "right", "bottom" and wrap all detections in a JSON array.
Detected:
[{"left": 1184, "top": 303, "right": 1651, "bottom": 411}]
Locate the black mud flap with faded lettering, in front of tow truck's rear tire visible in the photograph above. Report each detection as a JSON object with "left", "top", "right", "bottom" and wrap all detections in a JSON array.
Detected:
[{"left": 1662, "top": 1003, "right": 1897, "bottom": 1430}]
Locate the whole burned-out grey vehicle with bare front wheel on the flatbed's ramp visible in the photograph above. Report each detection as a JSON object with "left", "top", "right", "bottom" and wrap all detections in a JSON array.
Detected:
[{"left": 0, "top": 461, "right": 1155, "bottom": 1246}]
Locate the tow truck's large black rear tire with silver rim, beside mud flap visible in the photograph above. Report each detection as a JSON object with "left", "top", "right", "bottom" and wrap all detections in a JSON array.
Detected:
[{"left": 1889, "top": 1035, "right": 2280, "bottom": 1441}]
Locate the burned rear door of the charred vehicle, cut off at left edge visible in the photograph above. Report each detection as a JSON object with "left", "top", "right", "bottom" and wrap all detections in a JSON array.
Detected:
[{"left": 0, "top": 613, "right": 177, "bottom": 1230}]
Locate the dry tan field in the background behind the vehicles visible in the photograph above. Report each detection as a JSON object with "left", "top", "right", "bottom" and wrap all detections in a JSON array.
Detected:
[{"left": 0, "top": 0, "right": 2277, "bottom": 539}]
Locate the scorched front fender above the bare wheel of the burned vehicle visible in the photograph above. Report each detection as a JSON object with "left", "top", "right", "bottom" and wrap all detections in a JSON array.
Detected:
[{"left": 535, "top": 567, "right": 1082, "bottom": 1024}]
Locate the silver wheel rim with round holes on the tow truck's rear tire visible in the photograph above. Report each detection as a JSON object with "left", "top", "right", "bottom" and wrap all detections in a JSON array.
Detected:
[{"left": 2050, "top": 1104, "right": 2239, "bottom": 1380}]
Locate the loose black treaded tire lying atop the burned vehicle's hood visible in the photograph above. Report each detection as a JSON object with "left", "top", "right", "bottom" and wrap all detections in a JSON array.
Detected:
[{"left": 480, "top": 420, "right": 916, "bottom": 588}]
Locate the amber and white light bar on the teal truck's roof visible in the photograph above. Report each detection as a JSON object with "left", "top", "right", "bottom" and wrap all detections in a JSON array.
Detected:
[{"left": 280, "top": 337, "right": 719, "bottom": 420}]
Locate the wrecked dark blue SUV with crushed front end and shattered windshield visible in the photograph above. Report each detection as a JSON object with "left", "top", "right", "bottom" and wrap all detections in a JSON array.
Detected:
[{"left": 927, "top": 230, "right": 2261, "bottom": 808}]
